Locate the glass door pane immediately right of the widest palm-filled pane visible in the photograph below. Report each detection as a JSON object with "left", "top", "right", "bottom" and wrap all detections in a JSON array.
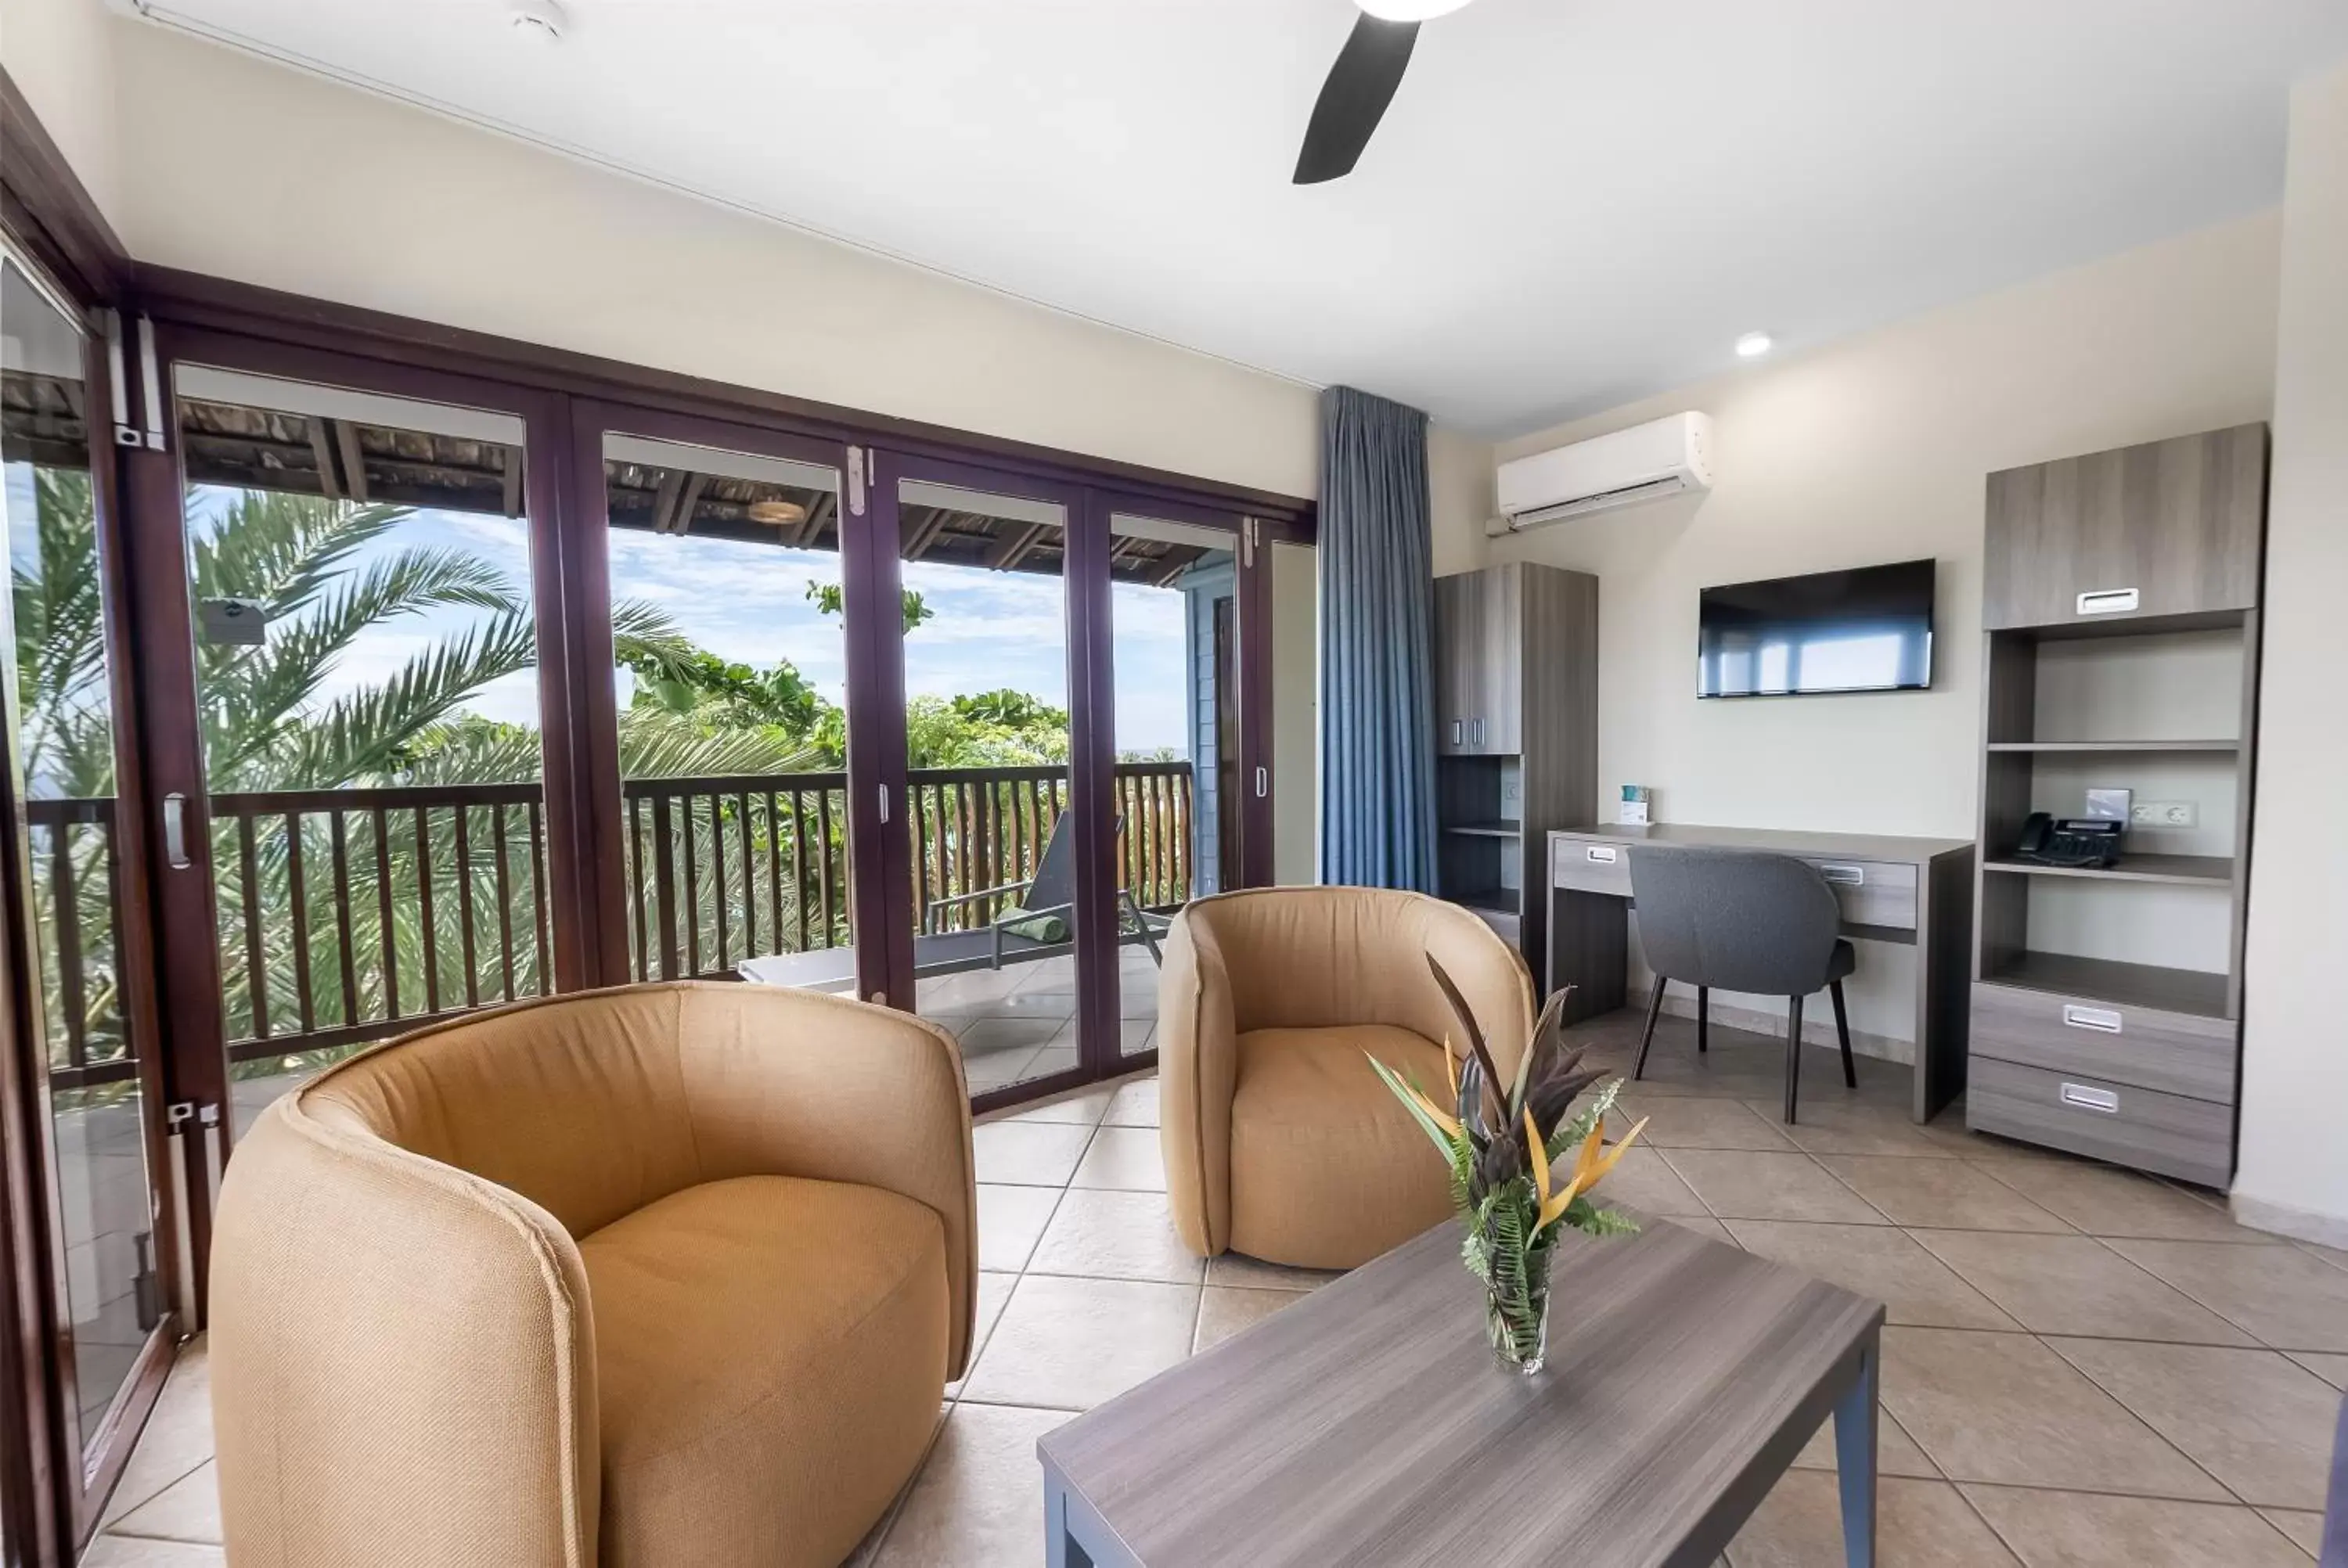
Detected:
[{"left": 603, "top": 434, "right": 857, "bottom": 991}]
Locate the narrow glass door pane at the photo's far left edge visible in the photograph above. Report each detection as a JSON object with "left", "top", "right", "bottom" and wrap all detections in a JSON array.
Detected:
[{"left": 0, "top": 263, "right": 162, "bottom": 1432}]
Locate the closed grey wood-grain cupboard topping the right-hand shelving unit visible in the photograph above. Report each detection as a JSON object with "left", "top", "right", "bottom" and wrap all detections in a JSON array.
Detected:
[{"left": 1982, "top": 425, "right": 2266, "bottom": 631}]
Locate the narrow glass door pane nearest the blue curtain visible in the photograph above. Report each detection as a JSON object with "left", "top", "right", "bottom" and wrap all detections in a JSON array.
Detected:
[{"left": 1108, "top": 514, "right": 1247, "bottom": 1056}]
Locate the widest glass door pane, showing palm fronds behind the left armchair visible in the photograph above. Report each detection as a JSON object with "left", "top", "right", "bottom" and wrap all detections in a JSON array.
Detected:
[{"left": 176, "top": 366, "right": 552, "bottom": 1129}]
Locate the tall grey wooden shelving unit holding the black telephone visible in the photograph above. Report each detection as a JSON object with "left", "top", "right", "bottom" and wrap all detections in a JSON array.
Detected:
[{"left": 1965, "top": 425, "right": 2266, "bottom": 1188}]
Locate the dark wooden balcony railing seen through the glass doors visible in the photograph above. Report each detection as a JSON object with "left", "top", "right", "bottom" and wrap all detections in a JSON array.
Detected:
[{"left": 31, "top": 763, "right": 1193, "bottom": 1089}]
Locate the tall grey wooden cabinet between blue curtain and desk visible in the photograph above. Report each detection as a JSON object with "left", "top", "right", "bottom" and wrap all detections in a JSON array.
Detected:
[{"left": 1435, "top": 563, "right": 1599, "bottom": 974}]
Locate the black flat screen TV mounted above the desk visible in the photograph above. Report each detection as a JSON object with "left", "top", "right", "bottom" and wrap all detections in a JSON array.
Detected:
[{"left": 1695, "top": 561, "right": 1932, "bottom": 697}]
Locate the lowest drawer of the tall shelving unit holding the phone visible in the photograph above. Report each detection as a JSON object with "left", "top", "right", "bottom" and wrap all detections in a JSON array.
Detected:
[{"left": 1965, "top": 1054, "right": 2233, "bottom": 1188}]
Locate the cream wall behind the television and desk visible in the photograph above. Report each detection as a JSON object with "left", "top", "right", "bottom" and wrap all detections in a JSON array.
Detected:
[{"left": 1437, "top": 214, "right": 2280, "bottom": 1040}]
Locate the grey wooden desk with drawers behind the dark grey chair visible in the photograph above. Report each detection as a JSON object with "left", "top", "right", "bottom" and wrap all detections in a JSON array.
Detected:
[{"left": 1545, "top": 822, "right": 1972, "bottom": 1122}]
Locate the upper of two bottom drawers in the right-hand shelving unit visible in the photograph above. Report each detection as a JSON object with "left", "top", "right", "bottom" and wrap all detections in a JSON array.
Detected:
[{"left": 1972, "top": 984, "right": 2235, "bottom": 1106}]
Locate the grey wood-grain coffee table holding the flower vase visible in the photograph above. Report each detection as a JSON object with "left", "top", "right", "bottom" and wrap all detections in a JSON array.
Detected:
[{"left": 1038, "top": 1221, "right": 1883, "bottom": 1568}]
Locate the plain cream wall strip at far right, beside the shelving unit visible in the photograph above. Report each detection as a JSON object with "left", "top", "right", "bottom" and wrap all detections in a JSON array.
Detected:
[{"left": 2233, "top": 55, "right": 2348, "bottom": 1246}]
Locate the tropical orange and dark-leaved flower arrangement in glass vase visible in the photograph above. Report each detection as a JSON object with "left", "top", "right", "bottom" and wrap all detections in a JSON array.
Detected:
[{"left": 1369, "top": 958, "right": 1646, "bottom": 1373}]
